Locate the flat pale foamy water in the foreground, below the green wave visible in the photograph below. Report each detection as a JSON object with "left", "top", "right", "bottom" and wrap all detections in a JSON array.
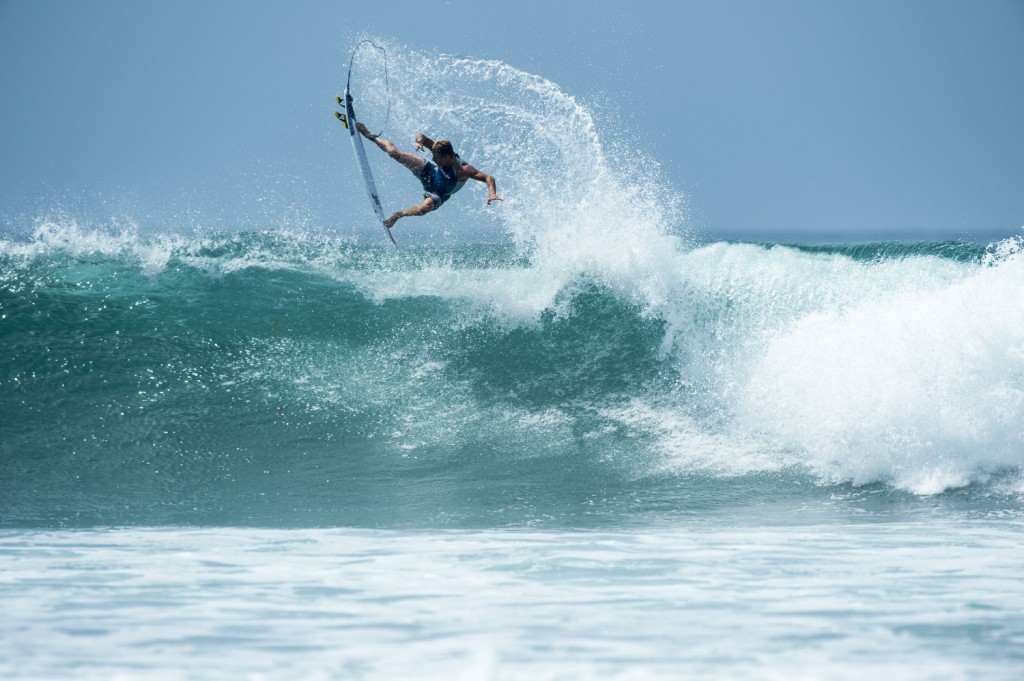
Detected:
[{"left": 0, "top": 518, "right": 1024, "bottom": 681}]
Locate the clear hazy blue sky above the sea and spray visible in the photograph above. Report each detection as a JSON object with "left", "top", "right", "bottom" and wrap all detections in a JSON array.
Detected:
[{"left": 0, "top": 0, "right": 1024, "bottom": 240}]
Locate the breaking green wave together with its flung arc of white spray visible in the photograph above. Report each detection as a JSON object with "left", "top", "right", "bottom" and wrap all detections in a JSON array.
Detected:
[{"left": 0, "top": 45, "right": 1024, "bottom": 525}]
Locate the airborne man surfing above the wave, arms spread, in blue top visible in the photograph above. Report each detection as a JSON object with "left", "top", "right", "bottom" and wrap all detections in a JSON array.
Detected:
[{"left": 355, "top": 123, "right": 502, "bottom": 229}]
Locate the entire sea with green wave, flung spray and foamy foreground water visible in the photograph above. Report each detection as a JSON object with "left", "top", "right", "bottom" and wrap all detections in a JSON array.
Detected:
[{"left": 6, "top": 43, "right": 1024, "bottom": 680}]
